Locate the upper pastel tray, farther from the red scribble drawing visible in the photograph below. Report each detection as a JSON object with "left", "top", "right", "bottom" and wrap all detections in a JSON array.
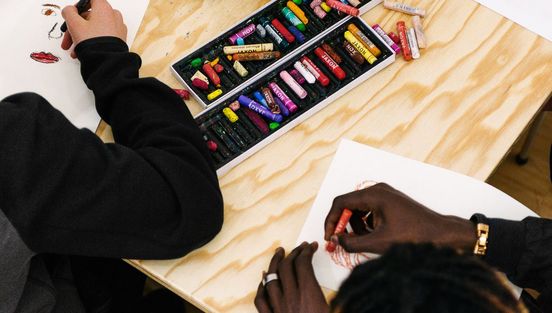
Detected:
[{"left": 172, "top": 0, "right": 382, "bottom": 107}]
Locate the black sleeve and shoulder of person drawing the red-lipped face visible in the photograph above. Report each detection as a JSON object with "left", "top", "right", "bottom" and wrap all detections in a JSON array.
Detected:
[{"left": 0, "top": 37, "right": 223, "bottom": 259}]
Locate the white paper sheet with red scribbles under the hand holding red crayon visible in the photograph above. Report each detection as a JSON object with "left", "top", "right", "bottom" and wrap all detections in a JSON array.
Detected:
[{"left": 297, "top": 140, "right": 536, "bottom": 290}]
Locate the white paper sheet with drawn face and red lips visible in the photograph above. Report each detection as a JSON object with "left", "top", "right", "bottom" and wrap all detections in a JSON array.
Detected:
[{"left": 0, "top": 0, "right": 149, "bottom": 131}]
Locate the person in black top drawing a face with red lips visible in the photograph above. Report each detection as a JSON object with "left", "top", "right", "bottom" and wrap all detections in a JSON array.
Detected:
[{"left": 0, "top": 0, "right": 223, "bottom": 313}]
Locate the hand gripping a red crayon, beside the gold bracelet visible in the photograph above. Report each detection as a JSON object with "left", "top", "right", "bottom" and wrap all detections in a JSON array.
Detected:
[{"left": 324, "top": 183, "right": 476, "bottom": 254}]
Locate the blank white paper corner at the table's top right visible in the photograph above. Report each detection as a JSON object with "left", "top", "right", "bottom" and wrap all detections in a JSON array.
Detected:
[{"left": 475, "top": 0, "right": 552, "bottom": 41}]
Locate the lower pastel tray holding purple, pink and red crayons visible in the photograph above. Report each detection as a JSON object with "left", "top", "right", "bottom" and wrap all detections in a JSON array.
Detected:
[{"left": 192, "top": 18, "right": 395, "bottom": 175}]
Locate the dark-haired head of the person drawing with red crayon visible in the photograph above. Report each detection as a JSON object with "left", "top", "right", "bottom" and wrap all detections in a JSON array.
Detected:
[{"left": 331, "top": 244, "right": 527, "bottom": 313}]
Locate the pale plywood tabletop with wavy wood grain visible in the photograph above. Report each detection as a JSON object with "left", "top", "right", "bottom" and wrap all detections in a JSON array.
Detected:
[{"left": 100, "top": 0, "right": 552, "bottom": 313}]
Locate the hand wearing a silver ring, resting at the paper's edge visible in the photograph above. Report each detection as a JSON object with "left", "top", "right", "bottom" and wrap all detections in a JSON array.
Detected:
[{"left": 255, "top": 242, "right": 329, "bottom": 313}]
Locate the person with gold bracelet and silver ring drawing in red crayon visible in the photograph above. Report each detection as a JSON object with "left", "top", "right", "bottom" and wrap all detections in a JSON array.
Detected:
[{"left": 255, "top": 180, "right": 552, "bottom": 313}]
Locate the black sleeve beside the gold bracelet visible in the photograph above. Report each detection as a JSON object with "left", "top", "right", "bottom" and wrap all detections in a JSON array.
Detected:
[{"left": 472, "top": 214, "right": 552, "bottom": 312}]
